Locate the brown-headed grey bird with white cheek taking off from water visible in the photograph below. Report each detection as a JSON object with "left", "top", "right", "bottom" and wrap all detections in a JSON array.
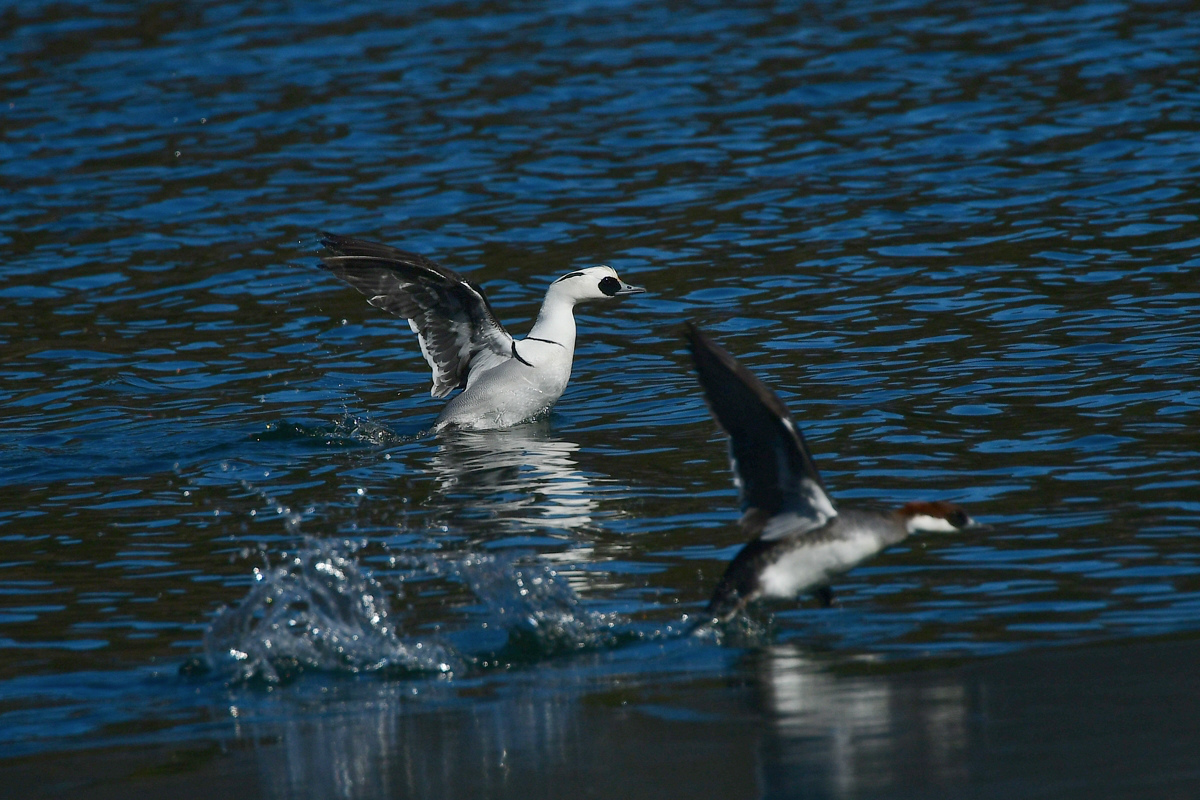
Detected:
[{"left": 686, "top": 324, "right": 974, "bottom": 620}]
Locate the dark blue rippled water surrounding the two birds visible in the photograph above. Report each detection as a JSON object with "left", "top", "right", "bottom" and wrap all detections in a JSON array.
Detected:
[{"left": 0, "top": 2, "right": 1200, "bottom": 798}]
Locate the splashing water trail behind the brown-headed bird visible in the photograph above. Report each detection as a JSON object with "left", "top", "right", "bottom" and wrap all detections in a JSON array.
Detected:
[{"left": 194, "top": 537, "right": 668, "bottom": 685}]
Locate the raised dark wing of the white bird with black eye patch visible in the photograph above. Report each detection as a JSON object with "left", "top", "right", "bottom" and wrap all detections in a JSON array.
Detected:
[{"left": 320, "top": 234, "right": 512, "bottom": 397}]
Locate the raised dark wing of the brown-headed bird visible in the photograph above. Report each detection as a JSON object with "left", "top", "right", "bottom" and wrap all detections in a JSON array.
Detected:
[{"left": 685, "top": 323, "right": 838, "bottom": 540}]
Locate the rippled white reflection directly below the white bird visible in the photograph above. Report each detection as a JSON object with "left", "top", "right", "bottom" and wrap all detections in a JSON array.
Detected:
[{"left": 431, "top": 421, "right": 596, "bottom": 530}]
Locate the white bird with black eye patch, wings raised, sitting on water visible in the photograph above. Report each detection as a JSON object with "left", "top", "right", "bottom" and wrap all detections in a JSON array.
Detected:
[{"left": 320, "top": 234, "right": 646, "bottom": 429}]
